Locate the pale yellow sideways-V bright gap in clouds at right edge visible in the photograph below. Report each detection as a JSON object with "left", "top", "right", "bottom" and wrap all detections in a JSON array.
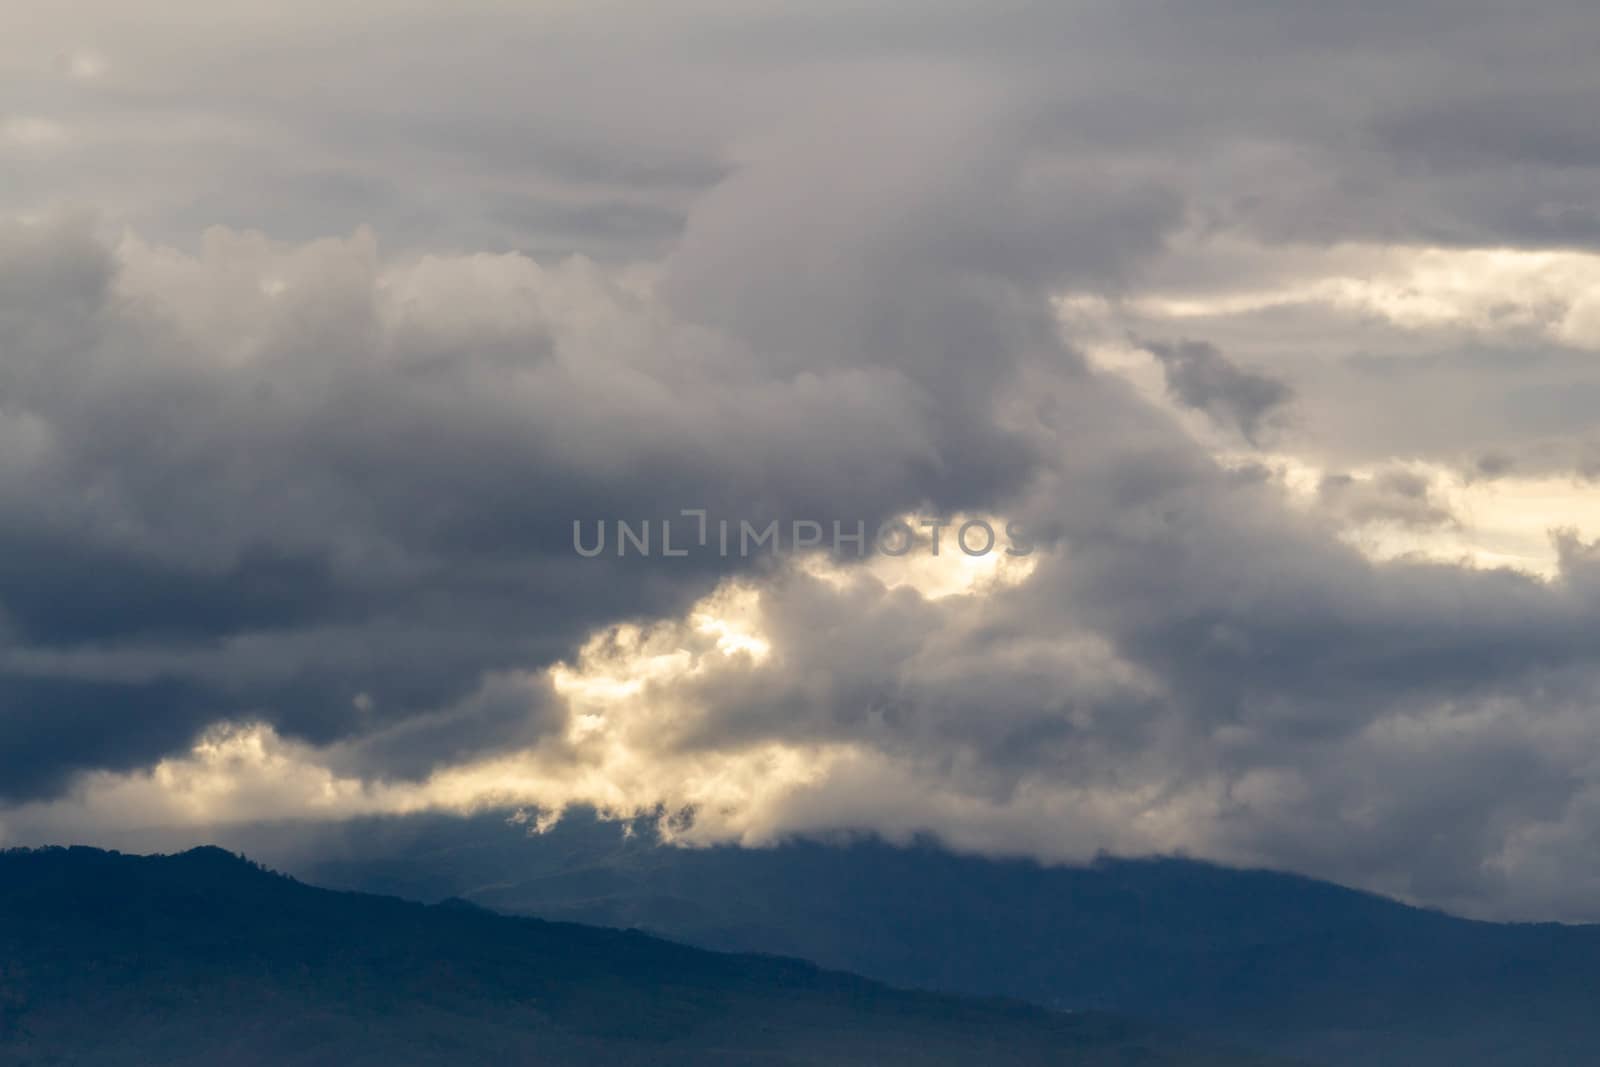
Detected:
[{"left": 1056, "top": 238, "right": 1600, "bottom": 577}]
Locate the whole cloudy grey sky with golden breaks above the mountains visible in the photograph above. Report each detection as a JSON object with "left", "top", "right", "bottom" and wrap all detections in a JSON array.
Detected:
[{"left": 0, "top": 0, "right": 1600, "bottom": 920}]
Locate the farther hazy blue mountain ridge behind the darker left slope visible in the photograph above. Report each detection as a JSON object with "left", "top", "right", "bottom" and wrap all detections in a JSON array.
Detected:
[{"left": 212, "top": 813, "right": 1600, "bottom": 1067}]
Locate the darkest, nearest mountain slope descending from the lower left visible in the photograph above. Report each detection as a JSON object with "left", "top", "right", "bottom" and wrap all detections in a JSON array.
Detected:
[{"left": 0, "top": 849, "right": 1292, "bottom": 1067}]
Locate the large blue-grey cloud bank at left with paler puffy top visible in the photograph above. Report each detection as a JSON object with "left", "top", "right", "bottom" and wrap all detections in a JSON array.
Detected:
[{"left": 0, "top": 199, "right": 1049, "bottom": 793}]
